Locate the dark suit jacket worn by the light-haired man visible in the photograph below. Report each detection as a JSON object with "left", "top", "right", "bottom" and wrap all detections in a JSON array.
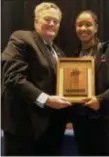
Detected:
[{"left": 1, "top": 31, "right": 67, "bottom": 138}]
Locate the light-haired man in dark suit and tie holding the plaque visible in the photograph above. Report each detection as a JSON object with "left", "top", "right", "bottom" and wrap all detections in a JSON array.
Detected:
[{"left": 2, "top": 3, "right": 71, "bottom": 156}]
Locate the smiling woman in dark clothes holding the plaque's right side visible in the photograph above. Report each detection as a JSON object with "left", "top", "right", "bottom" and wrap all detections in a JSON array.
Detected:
[{"left": 71, "top": 10, "right": 109, "bottom": 155}]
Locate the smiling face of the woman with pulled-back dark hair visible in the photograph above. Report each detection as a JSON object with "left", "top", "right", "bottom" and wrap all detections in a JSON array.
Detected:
[{"left": 76, "top": 13, "right": 97, "bottom": 43}]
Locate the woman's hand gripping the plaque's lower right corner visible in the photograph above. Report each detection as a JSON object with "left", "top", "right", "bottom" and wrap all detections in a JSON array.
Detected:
[{"left": 83, "top": 96, "right": 100, "bottom": 110}]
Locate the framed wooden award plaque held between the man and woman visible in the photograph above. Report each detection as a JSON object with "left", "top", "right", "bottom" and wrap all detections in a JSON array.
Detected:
[{"left": 57, "top": 57, "right": 95, "bottom": 103}]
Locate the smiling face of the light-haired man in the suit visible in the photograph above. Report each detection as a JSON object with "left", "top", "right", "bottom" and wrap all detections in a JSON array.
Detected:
[{"left": 35, "top": 8, "right": 60, "bottom": 41}]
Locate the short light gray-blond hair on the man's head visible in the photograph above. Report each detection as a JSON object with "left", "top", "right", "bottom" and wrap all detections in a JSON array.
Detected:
[{"left": 34, "top": 2, "right": 62, "bottom": 20}]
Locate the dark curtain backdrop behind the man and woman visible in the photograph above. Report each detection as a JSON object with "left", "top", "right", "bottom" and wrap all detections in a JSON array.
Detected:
[{"left": 1, "top": 0, "right": 109, "bottom": 56}]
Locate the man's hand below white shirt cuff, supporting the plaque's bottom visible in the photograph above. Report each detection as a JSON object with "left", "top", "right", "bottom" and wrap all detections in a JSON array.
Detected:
[{"left": 46, "top": 96, "right": 72, "bottom": 109}]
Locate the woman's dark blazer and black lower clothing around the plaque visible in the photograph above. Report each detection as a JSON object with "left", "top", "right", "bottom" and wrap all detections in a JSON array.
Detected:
[{"left": 70, "top": 42, "right": 109, "bottom": 155}]
